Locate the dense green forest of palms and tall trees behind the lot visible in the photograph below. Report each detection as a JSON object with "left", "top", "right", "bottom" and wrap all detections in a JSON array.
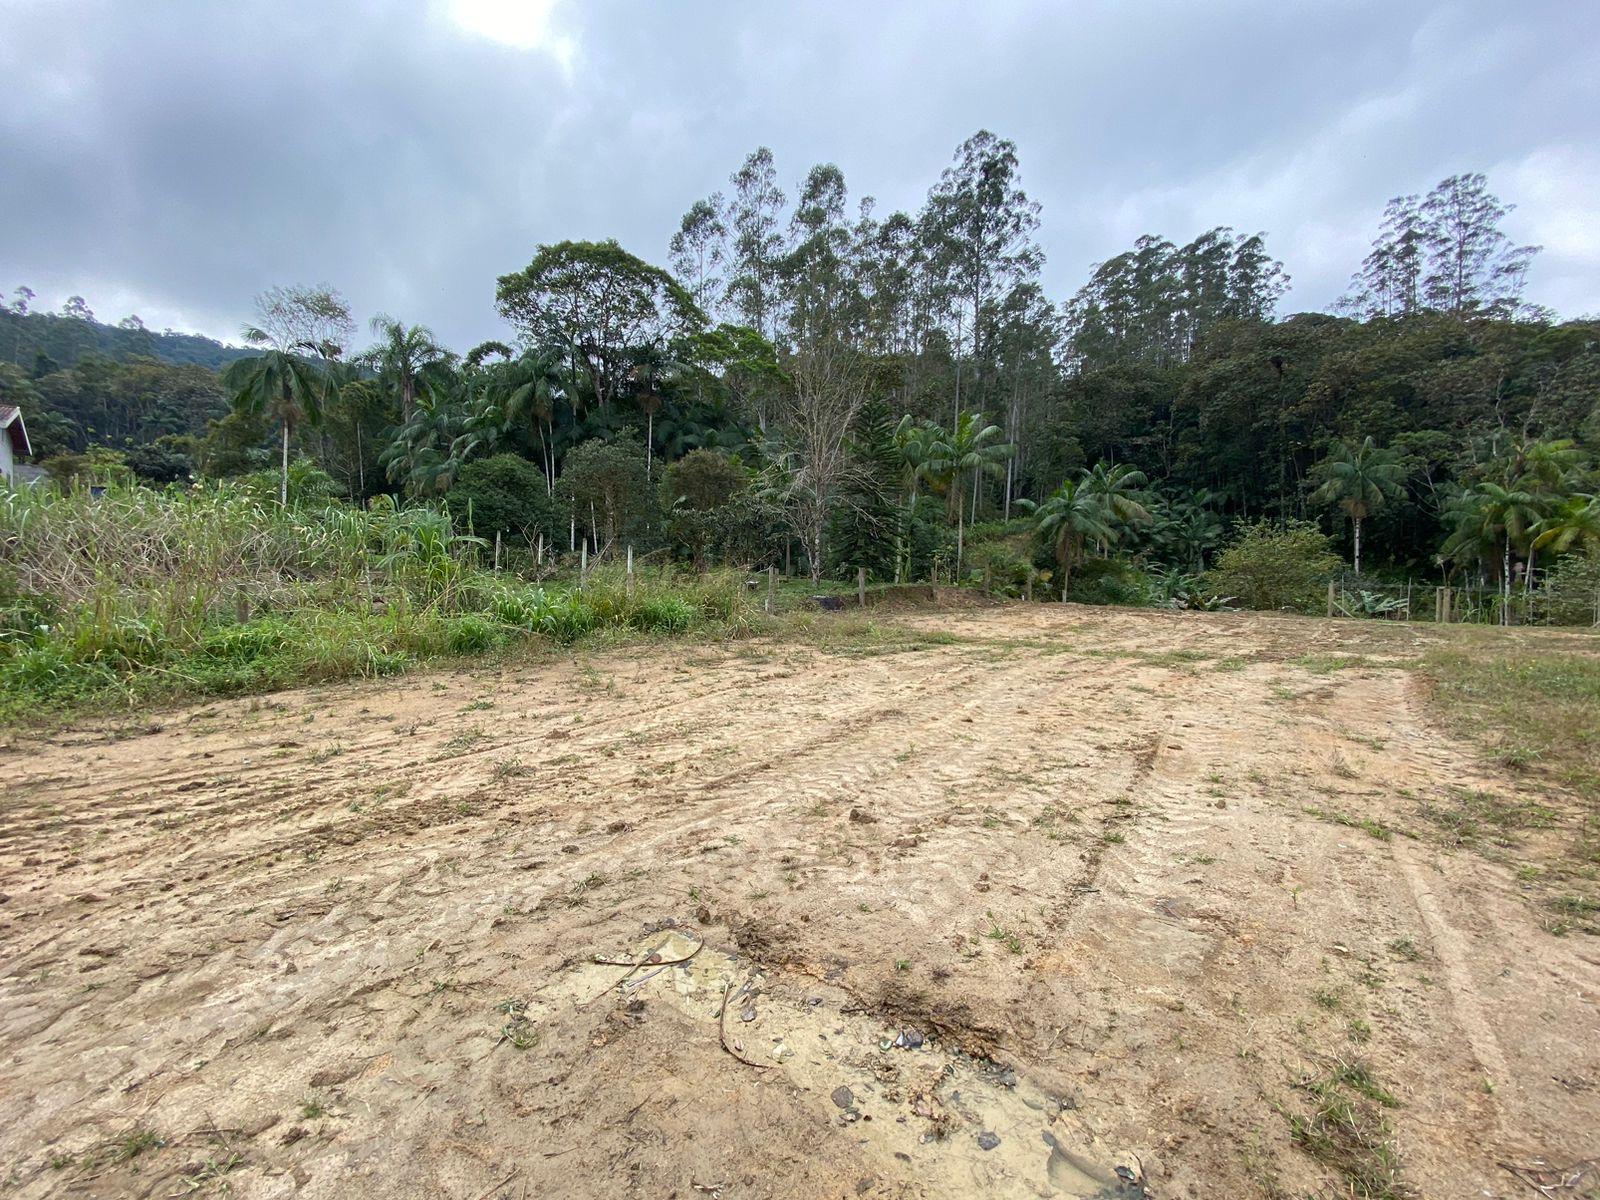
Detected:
[{"left": 0, "top": 133, "right": 1600, "bottom": 598}]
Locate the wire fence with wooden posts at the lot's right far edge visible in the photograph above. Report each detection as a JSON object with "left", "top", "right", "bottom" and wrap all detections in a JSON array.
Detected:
[{"left": 1328, "top": 571, "right": 1600, "bottom": 626}]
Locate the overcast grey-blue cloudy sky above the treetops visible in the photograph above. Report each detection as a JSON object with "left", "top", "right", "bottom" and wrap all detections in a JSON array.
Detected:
[{"left": 0, "top": 0, "right": 1600, "bottom": 349}]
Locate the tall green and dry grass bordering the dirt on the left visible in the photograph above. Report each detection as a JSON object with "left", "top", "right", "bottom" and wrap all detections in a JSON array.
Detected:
[{"left": 0, "top": 485, "right": 754, "bottom": 722}]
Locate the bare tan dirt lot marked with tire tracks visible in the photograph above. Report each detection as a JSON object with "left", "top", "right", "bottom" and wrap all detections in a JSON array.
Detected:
[{"left": 0, "top": 605, "right": 1600, "bottom": 1200}]
